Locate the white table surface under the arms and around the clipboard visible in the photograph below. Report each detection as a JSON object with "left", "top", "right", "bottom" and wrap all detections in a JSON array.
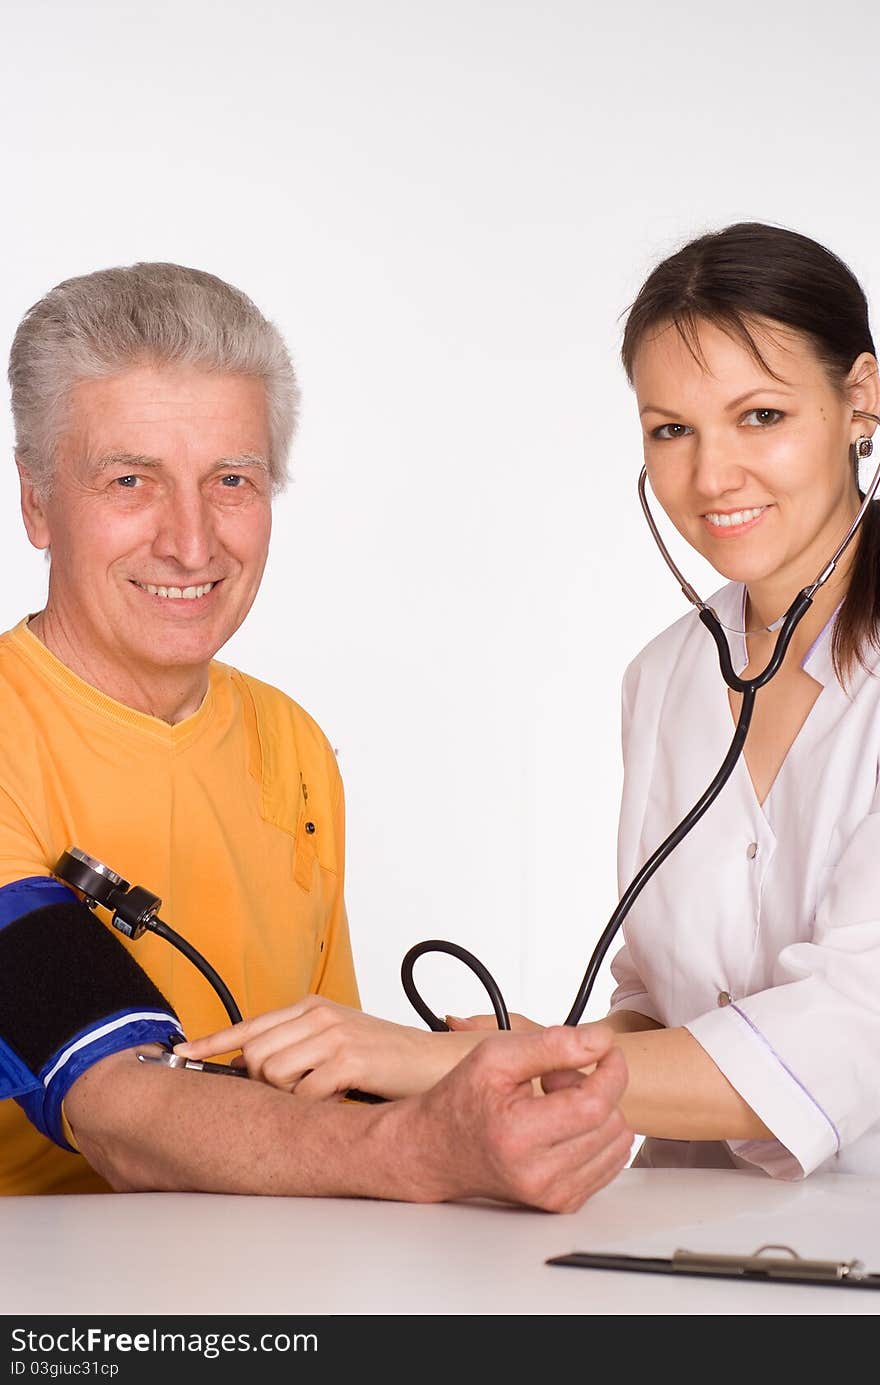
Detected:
[{"left": 0, "top": 1169, "right": 880, "bottom": 1316}]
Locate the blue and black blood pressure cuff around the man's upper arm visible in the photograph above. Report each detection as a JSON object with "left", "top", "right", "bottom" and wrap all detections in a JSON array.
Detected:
[{"left": 0, "top": 875, "right": 184, "bottom": 1150}]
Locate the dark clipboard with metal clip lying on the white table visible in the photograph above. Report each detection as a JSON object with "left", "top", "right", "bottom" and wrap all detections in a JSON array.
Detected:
[{"left": 545, "top": 1245, "right": 880, "bottom": 1289}]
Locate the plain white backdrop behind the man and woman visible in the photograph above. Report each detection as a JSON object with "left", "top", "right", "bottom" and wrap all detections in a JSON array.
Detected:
[{"left": 0, "top": 0, "right": 880, "bottom": 1025}]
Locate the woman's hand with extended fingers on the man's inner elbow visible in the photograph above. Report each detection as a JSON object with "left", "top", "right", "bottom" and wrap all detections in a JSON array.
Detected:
[{"left": 175, "top": 996, "right": 485, "bottom": 1100}]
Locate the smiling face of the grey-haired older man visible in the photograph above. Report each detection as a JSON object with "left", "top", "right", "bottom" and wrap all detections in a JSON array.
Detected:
[{"left": 24, "top": 364, "right": 272, "bottom": 681}]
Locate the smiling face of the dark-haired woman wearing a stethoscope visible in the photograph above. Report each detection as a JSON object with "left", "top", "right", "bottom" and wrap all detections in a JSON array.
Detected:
[{"left": 632, "top": 319, "right": 876, "bottom": 594}]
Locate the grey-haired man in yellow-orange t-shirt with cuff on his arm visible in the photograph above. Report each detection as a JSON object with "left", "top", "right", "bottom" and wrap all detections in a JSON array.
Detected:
[{"left": 0, "top": 263, "right": 631, "bottom": 1210}]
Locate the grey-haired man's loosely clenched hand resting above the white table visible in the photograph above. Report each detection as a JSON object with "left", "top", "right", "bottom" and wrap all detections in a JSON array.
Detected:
[{"left": 407, "top": 1024, "right": 633, "bottom": 1212}]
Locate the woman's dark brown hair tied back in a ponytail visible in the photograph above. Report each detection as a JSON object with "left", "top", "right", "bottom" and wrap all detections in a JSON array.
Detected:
[{"left": 621, "top": 222, "right": 880, "bottom": 683}]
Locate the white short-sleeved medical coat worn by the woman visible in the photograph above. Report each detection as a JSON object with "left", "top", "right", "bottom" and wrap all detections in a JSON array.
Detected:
[{"left": 611, "top": 583, "right": 880, "bottom": 1179}]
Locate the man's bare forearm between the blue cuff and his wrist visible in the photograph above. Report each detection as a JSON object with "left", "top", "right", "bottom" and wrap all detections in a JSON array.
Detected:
[{"left": 67, "top": 1051, "right": 446, "bottom": 1201}]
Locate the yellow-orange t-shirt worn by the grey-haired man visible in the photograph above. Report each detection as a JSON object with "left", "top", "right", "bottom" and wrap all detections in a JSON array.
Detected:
[{"left": 0, "top": 620, "right": 360, "bottom": 1195}]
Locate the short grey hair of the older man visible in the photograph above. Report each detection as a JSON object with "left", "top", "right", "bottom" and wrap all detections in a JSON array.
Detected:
[{"left": 8, "top": 263, "right": 299, "bottom": 494}]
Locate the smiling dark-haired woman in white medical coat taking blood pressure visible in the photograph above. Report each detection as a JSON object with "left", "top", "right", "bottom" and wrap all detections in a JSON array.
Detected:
[{"left": 175, "top": 223, "right": 880, "bottom": 1179}]
